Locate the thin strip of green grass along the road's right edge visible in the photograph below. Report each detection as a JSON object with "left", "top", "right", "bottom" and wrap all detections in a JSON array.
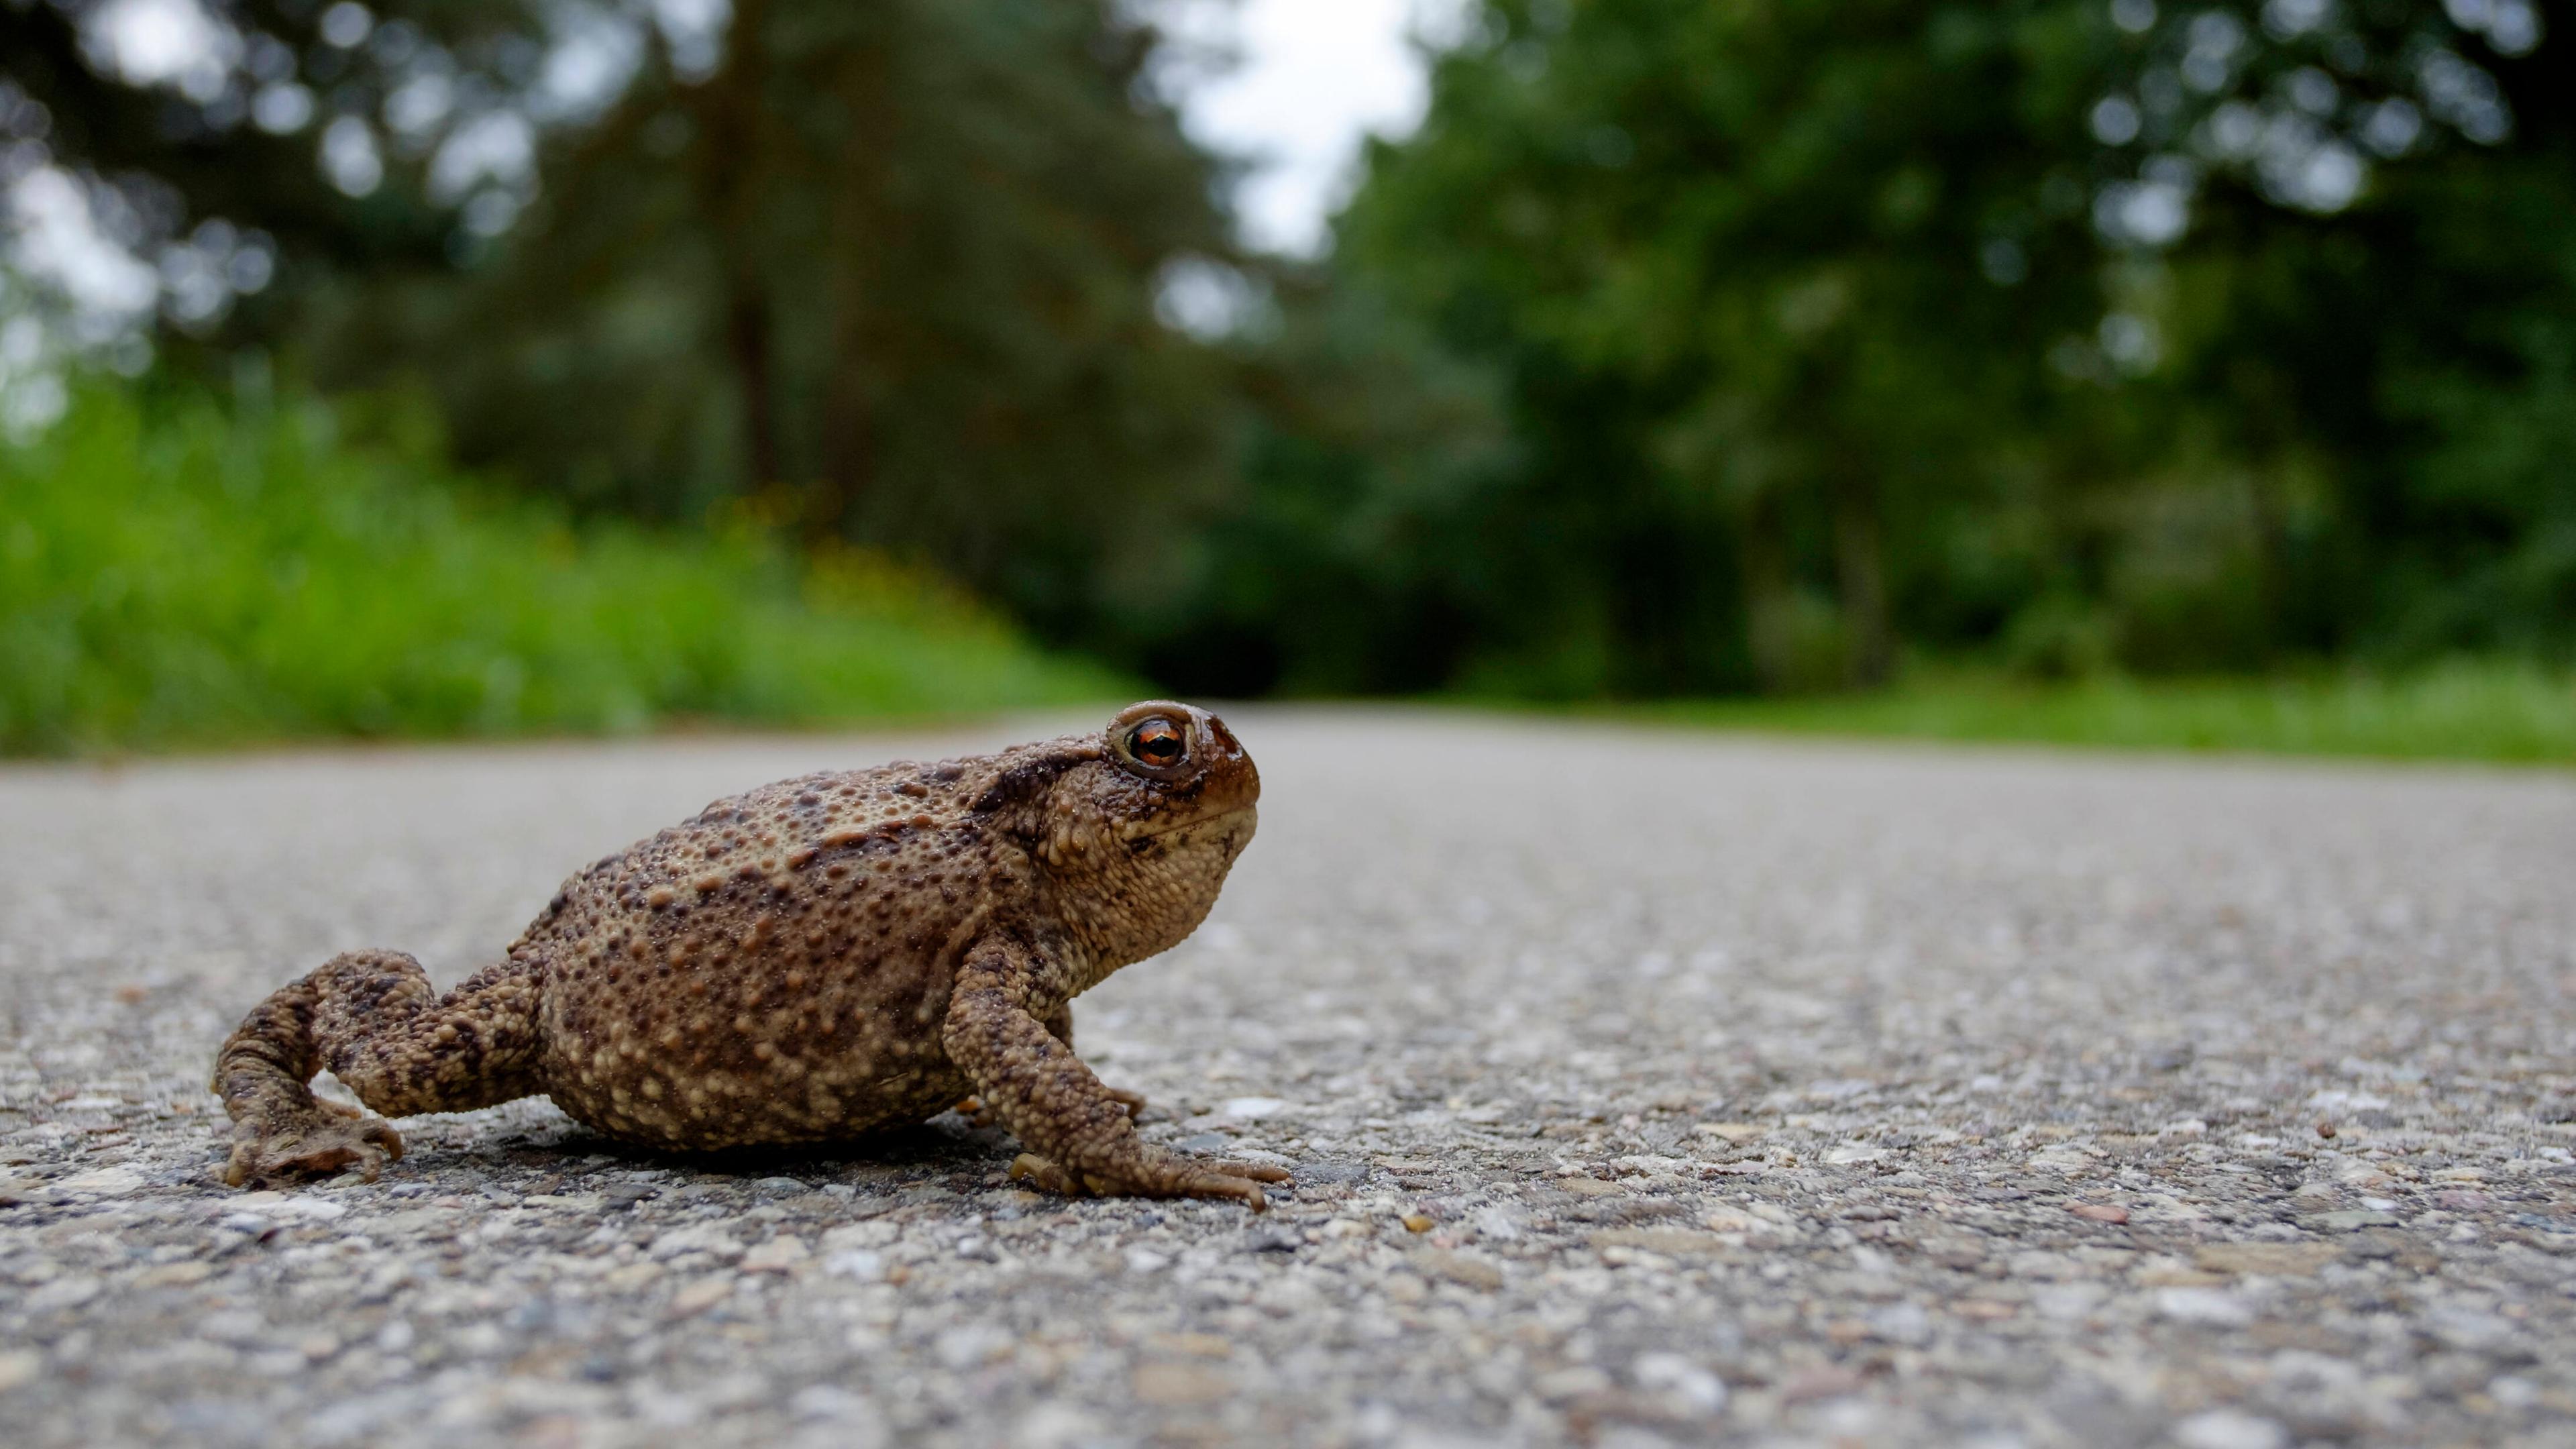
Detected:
[{"left": 1620, "top": 660, "right": 2576, "bottom": 765}]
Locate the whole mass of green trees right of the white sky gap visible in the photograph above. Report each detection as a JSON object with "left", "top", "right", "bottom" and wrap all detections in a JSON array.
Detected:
[{"left": 1175, "top": 0, "right": 2576, "bottom": 699}]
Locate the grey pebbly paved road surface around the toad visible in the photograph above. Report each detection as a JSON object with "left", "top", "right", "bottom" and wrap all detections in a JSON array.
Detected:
[{"left": 0, "top": 709, "right": 2576, "bottom": 1449}]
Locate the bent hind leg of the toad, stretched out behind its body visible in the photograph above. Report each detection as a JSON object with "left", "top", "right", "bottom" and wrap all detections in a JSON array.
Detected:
[{"left": 214, "top": 951, "right": 543, "bottom": 1186}]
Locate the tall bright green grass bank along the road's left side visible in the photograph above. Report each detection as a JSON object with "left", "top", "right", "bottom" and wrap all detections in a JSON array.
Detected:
[{"left": 0, "top": 387, "right": 1126, "bottom": 755}]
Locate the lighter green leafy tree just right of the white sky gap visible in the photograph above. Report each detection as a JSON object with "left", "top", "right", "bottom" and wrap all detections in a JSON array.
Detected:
[{"left": 1216, "top": 0, "right": 2115, "bottom": 694}]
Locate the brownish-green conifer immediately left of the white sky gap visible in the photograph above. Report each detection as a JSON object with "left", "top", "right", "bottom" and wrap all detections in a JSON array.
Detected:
[{"left": 301, "top": 0, "right": 1229, "bottom": 637}]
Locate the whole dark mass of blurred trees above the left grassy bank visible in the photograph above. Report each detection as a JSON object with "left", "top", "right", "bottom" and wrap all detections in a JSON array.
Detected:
[{"left": 0, "top": 0, "right": 1229, "bottom": 637}]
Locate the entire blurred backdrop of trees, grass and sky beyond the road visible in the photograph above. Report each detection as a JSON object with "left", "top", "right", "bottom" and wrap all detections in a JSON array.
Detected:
[{"left": 0, "top": 0, "right": 2576, "bottom": 761}]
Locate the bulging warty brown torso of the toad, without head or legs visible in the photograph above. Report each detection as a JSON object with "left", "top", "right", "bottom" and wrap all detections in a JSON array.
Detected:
[{"left": 513, "top": 761, "right": 1030, "bottom": 1147}]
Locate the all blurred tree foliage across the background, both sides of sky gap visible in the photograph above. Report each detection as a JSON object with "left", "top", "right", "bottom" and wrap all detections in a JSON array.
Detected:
[{"left": 0, "top": 0, "right": 2576, "bottom": 722}]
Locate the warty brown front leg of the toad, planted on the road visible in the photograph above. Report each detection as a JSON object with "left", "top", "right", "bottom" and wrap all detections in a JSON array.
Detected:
[{"left": 943, "top": 933, "right": 1288, "bottom": 1212}]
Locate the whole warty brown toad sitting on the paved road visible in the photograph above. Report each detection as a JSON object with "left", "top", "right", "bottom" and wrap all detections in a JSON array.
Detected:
[{"left": 214, "top": 701, "right": 1288, "bottom": 1210}]
